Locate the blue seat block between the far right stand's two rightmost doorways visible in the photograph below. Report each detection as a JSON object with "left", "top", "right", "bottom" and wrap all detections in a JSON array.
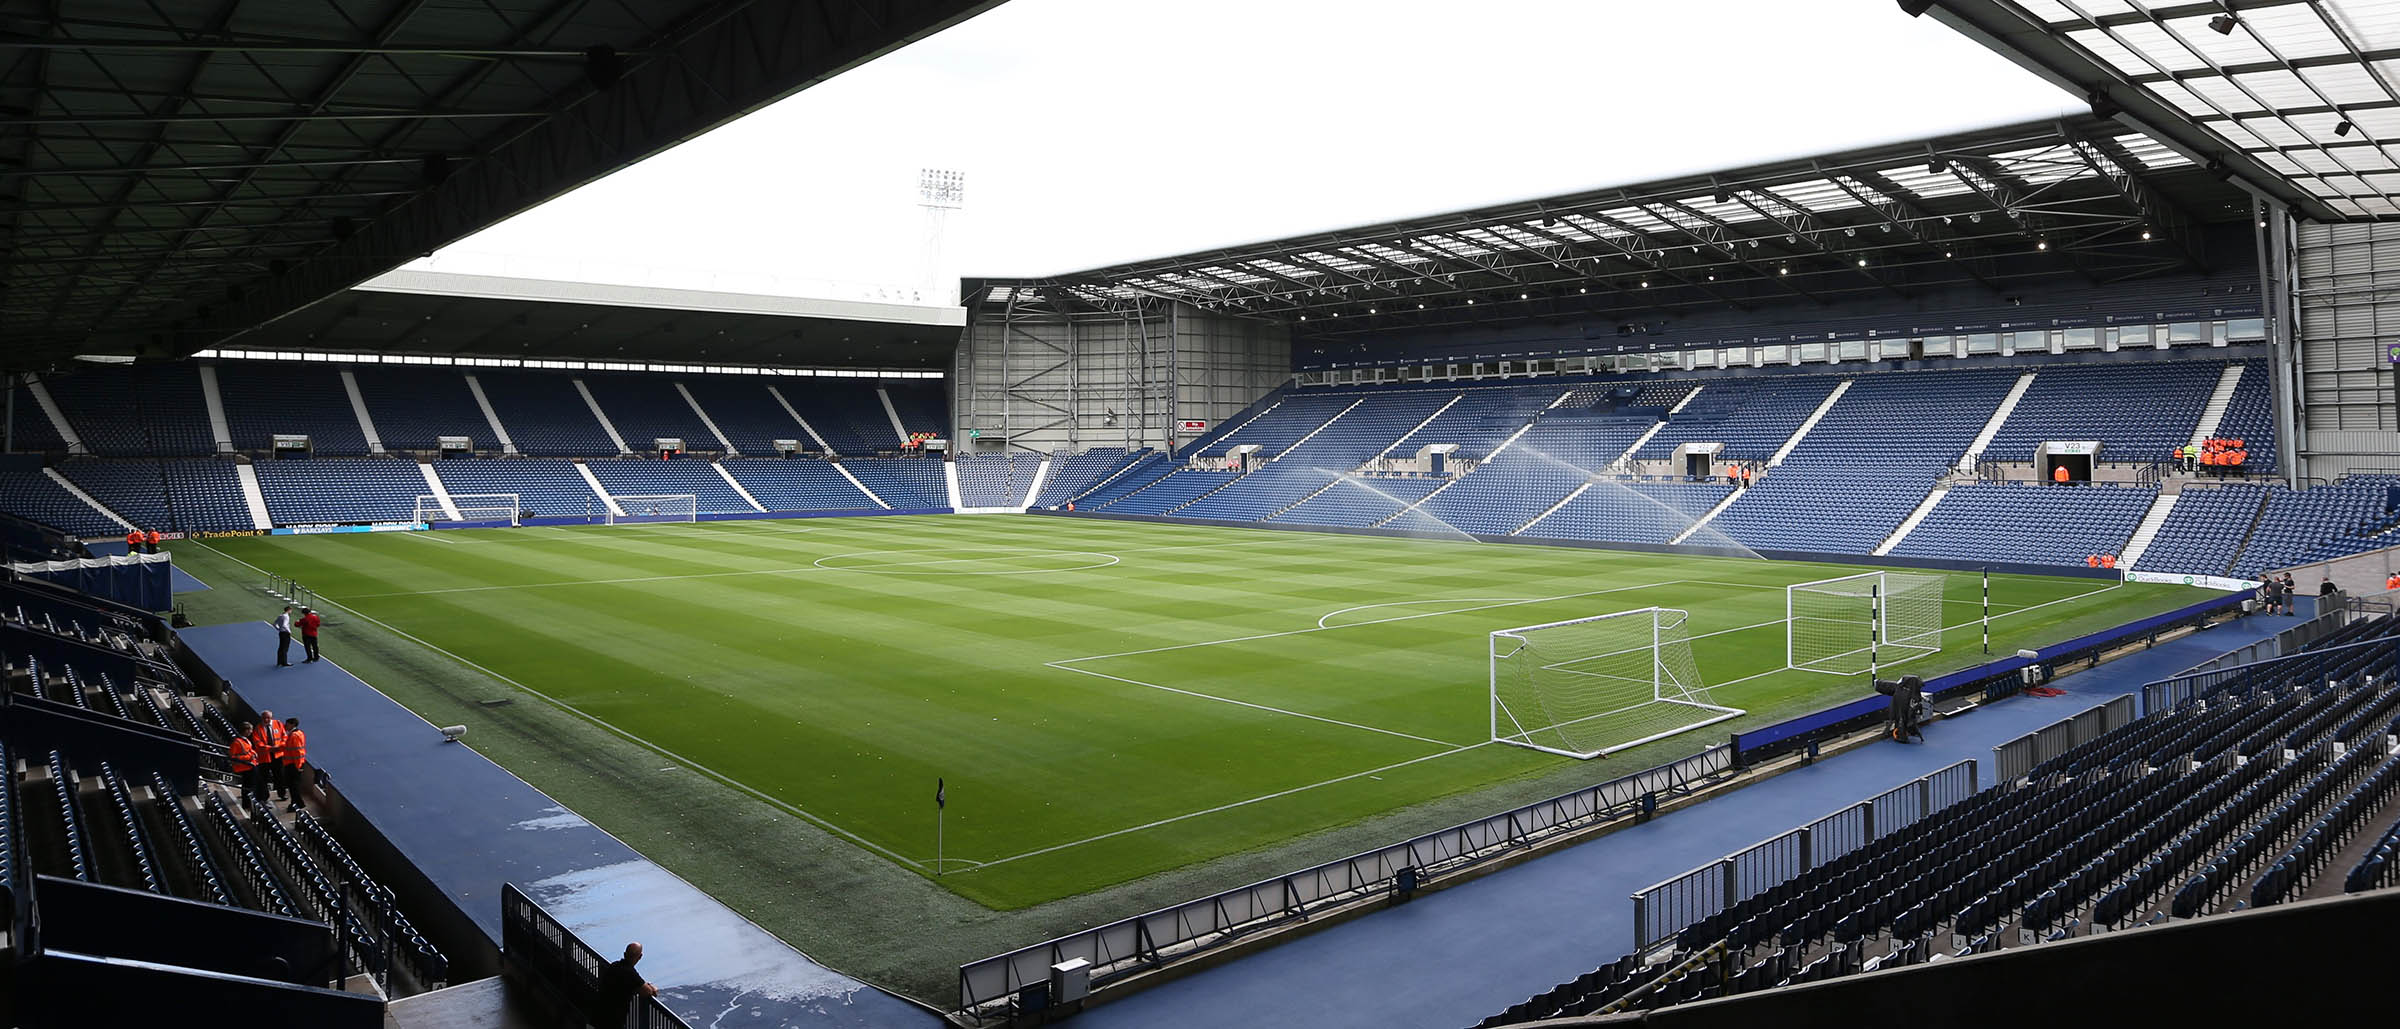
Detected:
[{"left": 1718, "top": 369, "right": 2016, "bottom": 554}]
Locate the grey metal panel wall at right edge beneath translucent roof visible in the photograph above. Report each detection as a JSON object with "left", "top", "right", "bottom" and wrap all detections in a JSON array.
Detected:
[{"left": 2297, "top": 223, "right": 2400, "bottom": 434}]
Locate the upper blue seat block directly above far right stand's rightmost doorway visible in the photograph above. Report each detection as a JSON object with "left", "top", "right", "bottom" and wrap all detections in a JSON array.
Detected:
[{"left": 1982, "top": 360, "right": 2225, "bottom": 463}]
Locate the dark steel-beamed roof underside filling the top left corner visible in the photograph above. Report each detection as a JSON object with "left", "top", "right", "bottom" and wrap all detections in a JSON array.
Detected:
[{"left": 0, "top": 0, "right": 998, "bottom": 367}]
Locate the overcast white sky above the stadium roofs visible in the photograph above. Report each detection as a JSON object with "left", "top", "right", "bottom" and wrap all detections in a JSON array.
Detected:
[{"left": 393, "top": 0, "right": 2078, "bottom": 302}]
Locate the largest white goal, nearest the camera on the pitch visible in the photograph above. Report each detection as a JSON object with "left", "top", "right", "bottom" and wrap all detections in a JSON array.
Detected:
[{"left": 1490, "top": 607, "right": 1742, "bottom": 758}]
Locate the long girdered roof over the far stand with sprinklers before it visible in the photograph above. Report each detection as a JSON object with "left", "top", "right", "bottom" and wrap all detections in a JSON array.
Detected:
[{"left": 965, "top": 118, "right": 2251, "bottom": 336}]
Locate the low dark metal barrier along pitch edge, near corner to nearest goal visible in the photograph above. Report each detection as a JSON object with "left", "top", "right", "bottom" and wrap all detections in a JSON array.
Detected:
[{"left": 958, "top": 746, "right": 1733, "bottom": 1022}]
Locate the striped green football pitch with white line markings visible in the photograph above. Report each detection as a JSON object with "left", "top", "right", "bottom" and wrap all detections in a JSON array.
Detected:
[{"left": 185, "top": 516, "right": 2206, "bottom": 909}]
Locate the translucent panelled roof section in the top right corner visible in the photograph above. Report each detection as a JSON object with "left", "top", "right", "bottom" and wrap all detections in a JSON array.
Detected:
[{"left": 1930, "top": 0, "right": 2400, "bottom": 221}]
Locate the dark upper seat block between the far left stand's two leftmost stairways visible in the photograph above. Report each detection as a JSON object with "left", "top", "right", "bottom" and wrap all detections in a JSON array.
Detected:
[{"left": 41, "top": 362, "right": 216, "bottom": 458}]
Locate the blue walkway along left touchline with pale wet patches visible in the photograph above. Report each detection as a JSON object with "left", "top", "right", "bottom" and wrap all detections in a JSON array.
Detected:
[{"left": 182, "top": 624, "right": 941, "bottom": 1029}]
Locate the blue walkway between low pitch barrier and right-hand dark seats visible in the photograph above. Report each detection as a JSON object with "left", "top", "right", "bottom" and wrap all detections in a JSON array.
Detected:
[{"left": 1075, "top": 604, "right": 2299, "bottom": 1029}]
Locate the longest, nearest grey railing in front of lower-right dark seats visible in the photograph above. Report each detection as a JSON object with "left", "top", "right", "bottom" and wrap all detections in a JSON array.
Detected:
[{"left": 1634, "top": 758, "right": 1975, "bottom": 950}]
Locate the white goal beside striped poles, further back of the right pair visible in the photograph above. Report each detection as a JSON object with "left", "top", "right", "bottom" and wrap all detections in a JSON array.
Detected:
[{"left": 1783, "top": 571, "right": 1942, "bottom": 676}]
